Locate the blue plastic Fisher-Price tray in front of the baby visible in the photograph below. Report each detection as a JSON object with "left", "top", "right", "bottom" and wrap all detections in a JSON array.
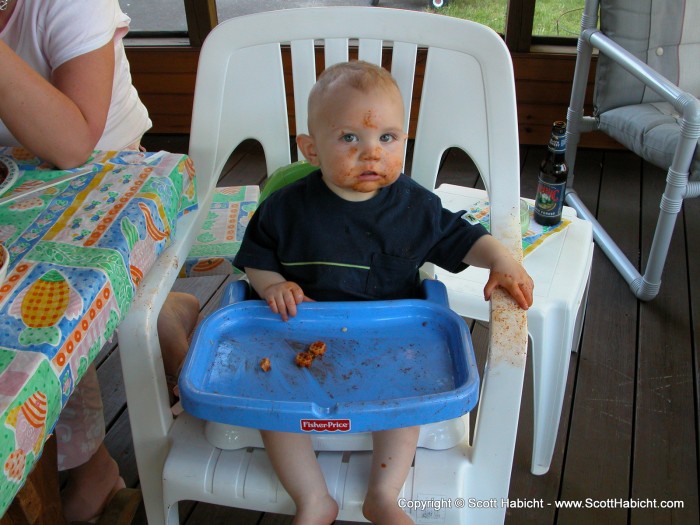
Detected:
[{"left": 180, "top": 281, "right": 479, "bottom": 432}]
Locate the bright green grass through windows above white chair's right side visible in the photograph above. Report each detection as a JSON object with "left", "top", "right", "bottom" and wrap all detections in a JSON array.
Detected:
[{"left": 440, "top": 0, "right": 584, "bottom": 38}]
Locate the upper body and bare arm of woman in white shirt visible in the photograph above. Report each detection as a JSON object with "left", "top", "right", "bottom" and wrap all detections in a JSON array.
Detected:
[{"left": 0, "top": 0, "right": 151, "bottom": 168}]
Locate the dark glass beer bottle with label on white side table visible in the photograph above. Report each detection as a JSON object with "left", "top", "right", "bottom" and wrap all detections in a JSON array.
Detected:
[{"left": 534, "top": 120, "right": 569, "bottom": 226}]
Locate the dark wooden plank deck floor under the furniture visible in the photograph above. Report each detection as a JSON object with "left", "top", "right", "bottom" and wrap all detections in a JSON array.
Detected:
[{"left": 98, "top": 136, "right": 700, "bottom": 525}]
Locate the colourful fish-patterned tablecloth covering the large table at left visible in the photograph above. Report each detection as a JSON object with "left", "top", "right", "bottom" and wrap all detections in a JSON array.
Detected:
[{"left": 0, "top": 148, "right": 196, "bottom": 516}]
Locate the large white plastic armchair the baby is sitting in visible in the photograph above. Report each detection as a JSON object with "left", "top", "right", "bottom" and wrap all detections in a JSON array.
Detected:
[{"left": 119, "top": 7, "right": 527, "bottom": 525}]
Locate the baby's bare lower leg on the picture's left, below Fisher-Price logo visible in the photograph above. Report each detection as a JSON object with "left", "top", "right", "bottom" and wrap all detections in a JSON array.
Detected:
[{"left": 260, "top": 430, "right": 338, "bottom": 525}]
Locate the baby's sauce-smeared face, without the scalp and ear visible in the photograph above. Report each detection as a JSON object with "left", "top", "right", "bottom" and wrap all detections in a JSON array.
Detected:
[{"left": 312, "top": 87, "right": 406, "bottom": 201}]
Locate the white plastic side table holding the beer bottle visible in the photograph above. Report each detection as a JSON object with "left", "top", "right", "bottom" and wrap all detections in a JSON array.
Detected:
[{"left": 434, "top": 191, "right": 593, "bottom": 475}]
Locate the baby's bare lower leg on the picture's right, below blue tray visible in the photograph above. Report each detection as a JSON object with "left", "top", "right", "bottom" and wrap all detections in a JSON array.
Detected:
[{"left": 362, "top": 427, "right": 420, "bottom": 525}]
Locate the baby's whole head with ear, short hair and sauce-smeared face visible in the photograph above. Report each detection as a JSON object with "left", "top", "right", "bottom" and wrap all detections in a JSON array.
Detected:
[{"left": 298, "top": 61, "right": 407, "bottom": 201}]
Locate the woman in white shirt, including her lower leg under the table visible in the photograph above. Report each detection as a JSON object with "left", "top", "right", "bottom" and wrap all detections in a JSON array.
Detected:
[{"left": 0, "top": 0, "right": 151, "bottom": 522}]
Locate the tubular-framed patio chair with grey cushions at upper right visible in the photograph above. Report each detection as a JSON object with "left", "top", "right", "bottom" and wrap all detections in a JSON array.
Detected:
[{"left": 566, "top": 0, "right": 700, "bottom": 301}]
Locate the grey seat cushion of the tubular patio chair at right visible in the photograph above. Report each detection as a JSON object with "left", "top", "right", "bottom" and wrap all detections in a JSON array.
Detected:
[{"left": 598, "top": 102, "right": 700, "bottom": 178}]
